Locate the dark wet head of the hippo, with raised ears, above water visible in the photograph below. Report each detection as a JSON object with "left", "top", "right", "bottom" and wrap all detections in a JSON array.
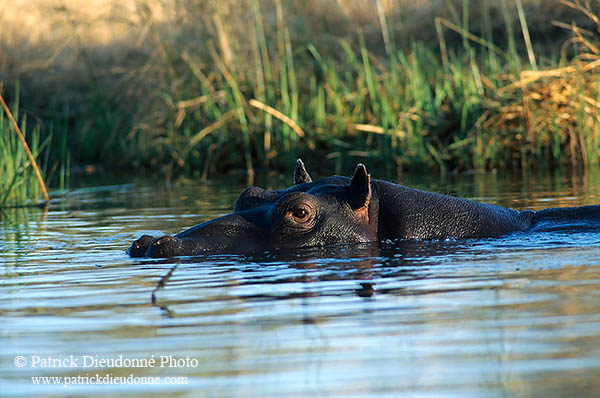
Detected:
[{"left": 128, "top": 160, "right": 378, "bottom": 257}]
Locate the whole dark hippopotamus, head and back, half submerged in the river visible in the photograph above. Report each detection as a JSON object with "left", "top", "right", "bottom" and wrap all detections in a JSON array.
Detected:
[{"left": 128, "top": 159, "right": 600, "bottom": 257}]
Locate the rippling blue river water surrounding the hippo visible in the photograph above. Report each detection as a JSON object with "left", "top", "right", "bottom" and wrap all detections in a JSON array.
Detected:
[{"left": 0, "top": 175, "right": 600, "bottom": 397}]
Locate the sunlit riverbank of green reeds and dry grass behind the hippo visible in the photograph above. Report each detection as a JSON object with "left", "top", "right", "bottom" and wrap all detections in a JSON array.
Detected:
[{"left": 0, "top": 0, "right": 600, "bottom": 182}]
